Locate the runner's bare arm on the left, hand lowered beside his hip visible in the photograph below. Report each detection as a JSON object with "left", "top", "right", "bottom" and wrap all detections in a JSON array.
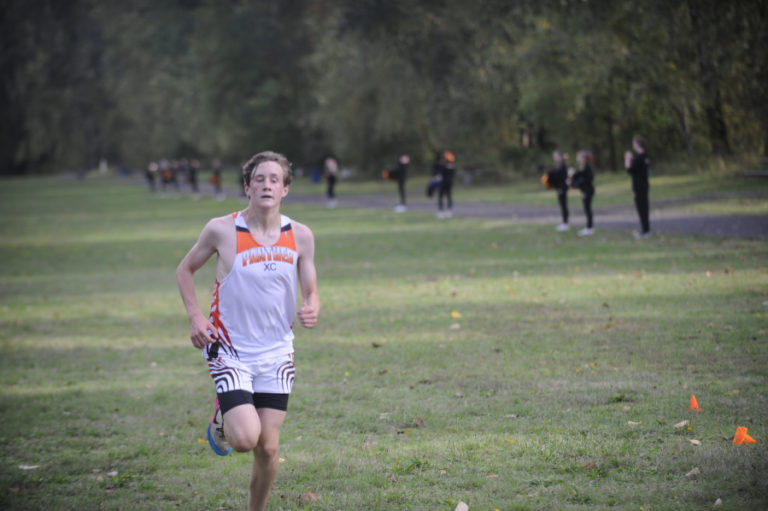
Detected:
[{"left": 176, "top": 218, "right": 226, "bottom": 348}]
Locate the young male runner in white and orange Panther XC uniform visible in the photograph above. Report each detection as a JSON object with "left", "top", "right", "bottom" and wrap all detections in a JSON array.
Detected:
[{"left": 176, "top": 152, "right": 320, "bottom": 510}]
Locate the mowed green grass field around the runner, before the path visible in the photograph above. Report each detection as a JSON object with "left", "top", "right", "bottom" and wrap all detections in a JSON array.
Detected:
[{"left": 0, "top": 178, "right": 768, "bottom": 511}]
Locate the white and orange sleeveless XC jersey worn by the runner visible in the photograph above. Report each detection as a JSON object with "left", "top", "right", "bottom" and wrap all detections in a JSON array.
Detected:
[{"left": 203, "top": 211, "right": 298, "bottom": 361}]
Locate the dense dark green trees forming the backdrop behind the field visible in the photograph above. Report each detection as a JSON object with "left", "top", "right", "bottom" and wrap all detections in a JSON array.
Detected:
[{"left": 0, "top": 0, "right": 768, "bottom": 174}]
